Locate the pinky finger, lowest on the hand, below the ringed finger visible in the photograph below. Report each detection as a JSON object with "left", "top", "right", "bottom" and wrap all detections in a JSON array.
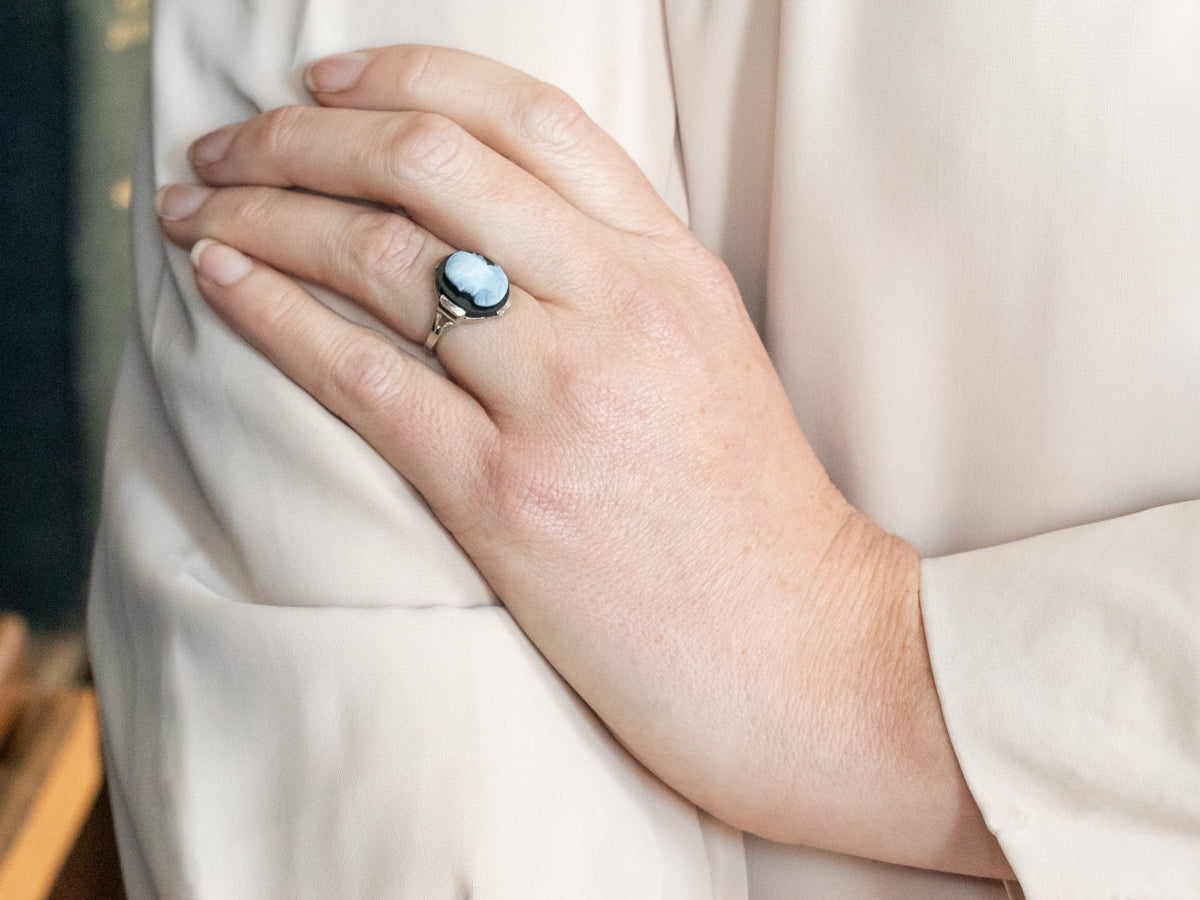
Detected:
[{"left": 192, "top": 239, "right": 494, "bottom": 520}]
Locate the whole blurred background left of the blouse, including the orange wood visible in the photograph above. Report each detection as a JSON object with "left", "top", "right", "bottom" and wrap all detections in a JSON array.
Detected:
[{"left": 0, "top": 0, "right": 150, "bottom": 900}]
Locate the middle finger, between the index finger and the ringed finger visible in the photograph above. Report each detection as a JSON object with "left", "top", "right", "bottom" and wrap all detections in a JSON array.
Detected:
[{"left": 192, "top": 107, "right": 612, "bottom": 301}]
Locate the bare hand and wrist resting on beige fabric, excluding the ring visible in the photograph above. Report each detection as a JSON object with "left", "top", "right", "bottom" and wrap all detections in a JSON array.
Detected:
[{"left": 150, "top": 47, "right": 1012, "bottom": 877}]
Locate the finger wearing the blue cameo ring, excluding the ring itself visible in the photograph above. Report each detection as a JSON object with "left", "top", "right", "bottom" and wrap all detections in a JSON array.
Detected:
[{"left": 156, "top": 185, "right": 550, "bottom": 414}]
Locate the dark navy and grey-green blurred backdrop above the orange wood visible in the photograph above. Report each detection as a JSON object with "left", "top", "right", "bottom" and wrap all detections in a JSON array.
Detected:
[{"left": 0, "top": 0, "right": 150, "bottom": 630}]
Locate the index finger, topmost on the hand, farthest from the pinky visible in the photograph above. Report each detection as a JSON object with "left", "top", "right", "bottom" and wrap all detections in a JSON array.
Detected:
[{"left": 305, "top": 44, "right": 680, "bottom": 243}]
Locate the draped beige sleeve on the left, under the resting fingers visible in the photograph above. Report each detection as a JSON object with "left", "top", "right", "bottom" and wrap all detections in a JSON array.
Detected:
[{"left": 89, "top": 0, "right": 746, "bottom": 900}]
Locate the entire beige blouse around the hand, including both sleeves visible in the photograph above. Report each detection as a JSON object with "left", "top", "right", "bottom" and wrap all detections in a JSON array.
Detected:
[{"left": 90, "top": 0, "right": 1200, "bottom": 900}]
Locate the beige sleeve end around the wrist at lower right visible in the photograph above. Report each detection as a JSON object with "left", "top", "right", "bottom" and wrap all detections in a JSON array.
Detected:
[{"left": 922, "top": 502, "right": 1200, "bottom": 900}]
